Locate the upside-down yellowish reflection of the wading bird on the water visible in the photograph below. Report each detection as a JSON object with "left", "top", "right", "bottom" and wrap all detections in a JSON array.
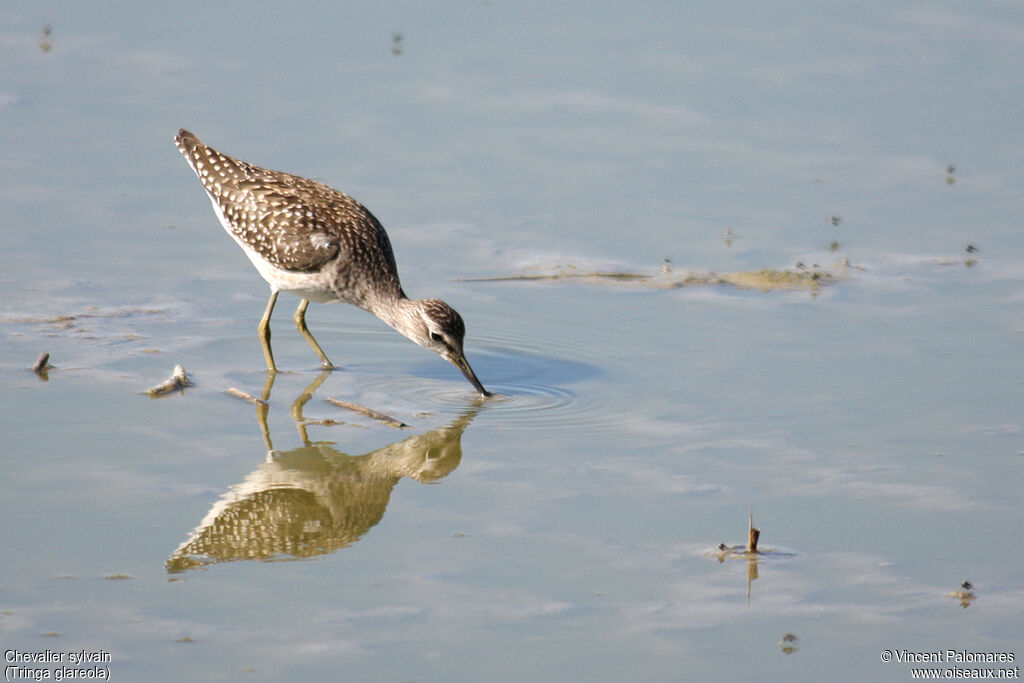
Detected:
[{"left": 165, "top": 372, "right": 480, "bottom": 573}]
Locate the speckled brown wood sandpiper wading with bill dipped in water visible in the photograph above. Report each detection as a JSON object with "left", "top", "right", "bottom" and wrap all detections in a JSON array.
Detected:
[{"left": 174, "top": 129, "right": 490, "bottom": 396}]
